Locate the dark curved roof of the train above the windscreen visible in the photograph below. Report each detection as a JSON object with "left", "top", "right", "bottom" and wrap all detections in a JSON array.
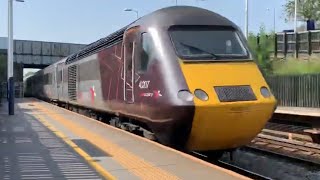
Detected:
[{"left": 65, "top": 6, "right": 239, "bottom": 64}]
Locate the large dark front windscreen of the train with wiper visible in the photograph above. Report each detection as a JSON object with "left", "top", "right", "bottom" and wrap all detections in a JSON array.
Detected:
[{"left": 169, "top": 26, "right": 249, "bottom": 60}]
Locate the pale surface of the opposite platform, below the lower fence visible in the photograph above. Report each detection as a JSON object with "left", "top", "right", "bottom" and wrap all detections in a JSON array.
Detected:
[{"left": 275, "top": 106, "right": 320, "bottom": 117}]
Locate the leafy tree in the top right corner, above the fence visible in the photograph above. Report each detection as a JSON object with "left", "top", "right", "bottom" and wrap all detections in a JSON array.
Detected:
[{"left": 284, "top": 0, "right": 320, "bottom": 21}]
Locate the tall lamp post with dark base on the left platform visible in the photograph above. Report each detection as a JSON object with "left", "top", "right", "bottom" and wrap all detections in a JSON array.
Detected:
[{"left": 8, "top": 0, "right": 24, "bottom": 115}]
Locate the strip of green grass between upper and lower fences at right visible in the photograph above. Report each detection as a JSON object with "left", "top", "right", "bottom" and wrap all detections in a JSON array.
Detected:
[{"left": 272, "top": 58, "right": 320, "bottom": 75}]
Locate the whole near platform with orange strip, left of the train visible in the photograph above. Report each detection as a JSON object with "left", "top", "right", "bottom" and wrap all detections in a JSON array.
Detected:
[{"left": 0, "top": 98, "right": 249, "bottom": 180}]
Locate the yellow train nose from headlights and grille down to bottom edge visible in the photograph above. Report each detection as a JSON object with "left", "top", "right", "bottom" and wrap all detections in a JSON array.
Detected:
[{"left": 180, "top": 85, "right": 274, "bottom": 151}]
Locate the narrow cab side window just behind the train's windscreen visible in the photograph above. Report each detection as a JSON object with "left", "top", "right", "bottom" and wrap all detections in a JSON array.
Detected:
[{"left": 138, "top": 33, "right": 153, "bottom": 72}]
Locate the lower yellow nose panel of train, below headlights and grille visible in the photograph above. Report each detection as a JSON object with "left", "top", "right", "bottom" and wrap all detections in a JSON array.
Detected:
[{"left": 187, "top": 104, "right": 273, "bottom": 151}]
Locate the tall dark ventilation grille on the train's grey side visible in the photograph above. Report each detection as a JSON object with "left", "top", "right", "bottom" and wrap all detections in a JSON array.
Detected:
[{"left": 68, "top": 65, "right": 77, "bottom": 101}]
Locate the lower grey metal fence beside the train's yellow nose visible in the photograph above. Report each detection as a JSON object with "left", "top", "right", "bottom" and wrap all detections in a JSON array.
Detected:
[{"left": 267, "top": 74, "right": 320, "bottom": 108}]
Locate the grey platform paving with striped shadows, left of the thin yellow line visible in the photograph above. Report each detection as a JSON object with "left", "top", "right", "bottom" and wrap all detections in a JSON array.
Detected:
[{"left": 0, "top": 114, "right": 103, "bottom": 180}]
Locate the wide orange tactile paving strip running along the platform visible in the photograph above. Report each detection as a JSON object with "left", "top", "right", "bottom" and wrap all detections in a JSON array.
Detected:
[{"left": 35, "top": 103, "right": 179, "bottom": 180}]
